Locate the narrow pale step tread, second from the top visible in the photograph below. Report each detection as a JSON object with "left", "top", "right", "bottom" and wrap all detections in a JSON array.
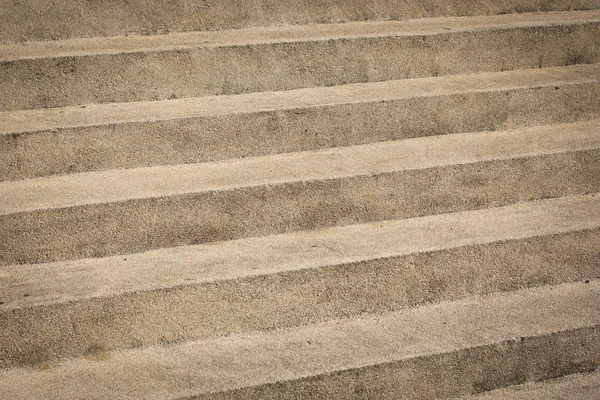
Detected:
[{"left": 0, "top": 64, "right": 600, "bottom": 135}]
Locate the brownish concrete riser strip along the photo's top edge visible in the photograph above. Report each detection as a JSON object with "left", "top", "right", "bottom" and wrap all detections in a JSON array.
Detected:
[{"left": 0, "top": 0, "right": 600, "bottom": 43}]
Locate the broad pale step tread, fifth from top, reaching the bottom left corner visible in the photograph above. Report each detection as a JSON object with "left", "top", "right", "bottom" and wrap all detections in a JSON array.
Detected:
[{"left": 0, "top": 280, "right": 600, "bottom": 399}]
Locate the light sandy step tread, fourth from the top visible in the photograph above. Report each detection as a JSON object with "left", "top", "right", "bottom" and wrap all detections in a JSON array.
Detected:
[{"left": 0, "top": 194, "right": 600, "bottom": 311}]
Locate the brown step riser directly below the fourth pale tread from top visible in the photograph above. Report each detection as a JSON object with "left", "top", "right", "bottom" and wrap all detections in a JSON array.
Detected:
[{"left": 0, "top": 229, "right": 600, "bottom": 368}]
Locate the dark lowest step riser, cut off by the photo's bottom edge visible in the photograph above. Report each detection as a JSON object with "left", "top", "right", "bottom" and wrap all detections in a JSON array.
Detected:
[{"left": 199, "top": 328, "right": 600, "bottom": 400}]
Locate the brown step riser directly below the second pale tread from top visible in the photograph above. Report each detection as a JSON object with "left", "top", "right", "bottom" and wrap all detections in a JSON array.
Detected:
[{"left": 0, "top": 82, "right": 600, "bottom": 180}]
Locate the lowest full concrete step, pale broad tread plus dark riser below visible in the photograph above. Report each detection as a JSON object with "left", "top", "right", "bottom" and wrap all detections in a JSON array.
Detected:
[{"left": 0, "top": 280, "right": 600, "bottom": 400}]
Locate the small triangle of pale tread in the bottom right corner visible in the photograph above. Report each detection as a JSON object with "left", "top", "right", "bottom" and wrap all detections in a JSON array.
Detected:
[{"left": 465, "top": 370, "right": 600, "bottom": 400}]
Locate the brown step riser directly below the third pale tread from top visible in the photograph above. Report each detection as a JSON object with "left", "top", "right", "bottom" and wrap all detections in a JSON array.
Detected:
[{"left": 0, "top": 149, "right": 600, "bottom": 265}]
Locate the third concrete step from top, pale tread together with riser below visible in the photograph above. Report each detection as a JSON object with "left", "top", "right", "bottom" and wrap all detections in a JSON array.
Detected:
[{"left": 0, "top": 120, "right": 600, "bottom": 265}]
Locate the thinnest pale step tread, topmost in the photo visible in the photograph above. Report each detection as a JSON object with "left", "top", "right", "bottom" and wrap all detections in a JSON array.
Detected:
[{"left": 0, "top": 10, "right": 600, "bottom": 62}]
